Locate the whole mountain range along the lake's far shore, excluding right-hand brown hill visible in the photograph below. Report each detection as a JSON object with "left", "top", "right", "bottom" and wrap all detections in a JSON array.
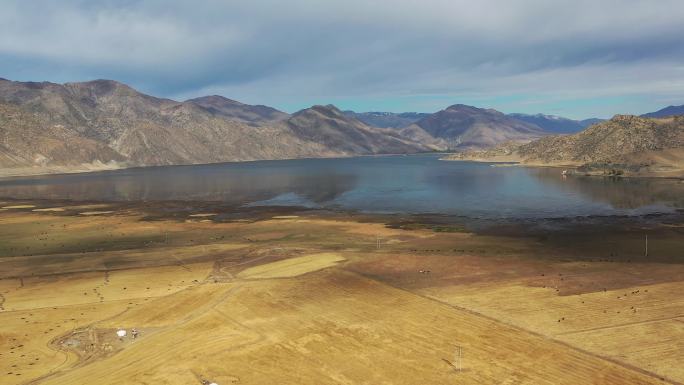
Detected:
[{"left": 0, "top": 79, "right": 676, "bottom": 175}]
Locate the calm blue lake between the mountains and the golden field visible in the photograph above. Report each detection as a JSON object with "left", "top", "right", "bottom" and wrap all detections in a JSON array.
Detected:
[{"left": 0, "top": 154, "right": 684, "bottom": 219}]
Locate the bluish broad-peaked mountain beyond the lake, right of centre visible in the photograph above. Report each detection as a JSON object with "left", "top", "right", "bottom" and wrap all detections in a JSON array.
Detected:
[{"left": 407, "top": 104, "right": 547, "bottom": 150}]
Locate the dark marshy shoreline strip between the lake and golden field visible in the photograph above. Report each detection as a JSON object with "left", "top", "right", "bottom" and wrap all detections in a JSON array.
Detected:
[{"left": 0, "top": 197, "right": 684, "bottom": 237}]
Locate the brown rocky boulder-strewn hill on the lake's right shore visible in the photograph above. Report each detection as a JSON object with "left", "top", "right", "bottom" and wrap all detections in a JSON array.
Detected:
[{"left": 446, "top": 115, "right": 684, "bottom": 177}]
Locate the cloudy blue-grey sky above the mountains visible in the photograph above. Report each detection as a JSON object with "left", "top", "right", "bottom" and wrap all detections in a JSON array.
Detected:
[{"left": 0, "top": 0, "right": 684, "bottom": 119}]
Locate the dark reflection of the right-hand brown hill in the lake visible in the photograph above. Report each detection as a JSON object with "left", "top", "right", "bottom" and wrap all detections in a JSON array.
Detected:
[{"left": 530, "top": 169, "right": 684, "bottom": 209}]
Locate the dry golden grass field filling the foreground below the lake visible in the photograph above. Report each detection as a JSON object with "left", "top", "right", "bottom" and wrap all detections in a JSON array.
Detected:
[{"left": 0, "top": 202, "right": 684, "bottom": 385}]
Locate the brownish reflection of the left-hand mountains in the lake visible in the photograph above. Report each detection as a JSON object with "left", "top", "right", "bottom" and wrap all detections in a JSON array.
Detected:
[{"left": 0, "top": 164, "right": 358, "bottom": 204}]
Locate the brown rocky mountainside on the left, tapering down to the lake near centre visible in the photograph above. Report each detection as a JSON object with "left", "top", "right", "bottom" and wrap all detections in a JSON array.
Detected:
[{"left": 0, "top": 80, "right": 428, "bottom": 172}]
